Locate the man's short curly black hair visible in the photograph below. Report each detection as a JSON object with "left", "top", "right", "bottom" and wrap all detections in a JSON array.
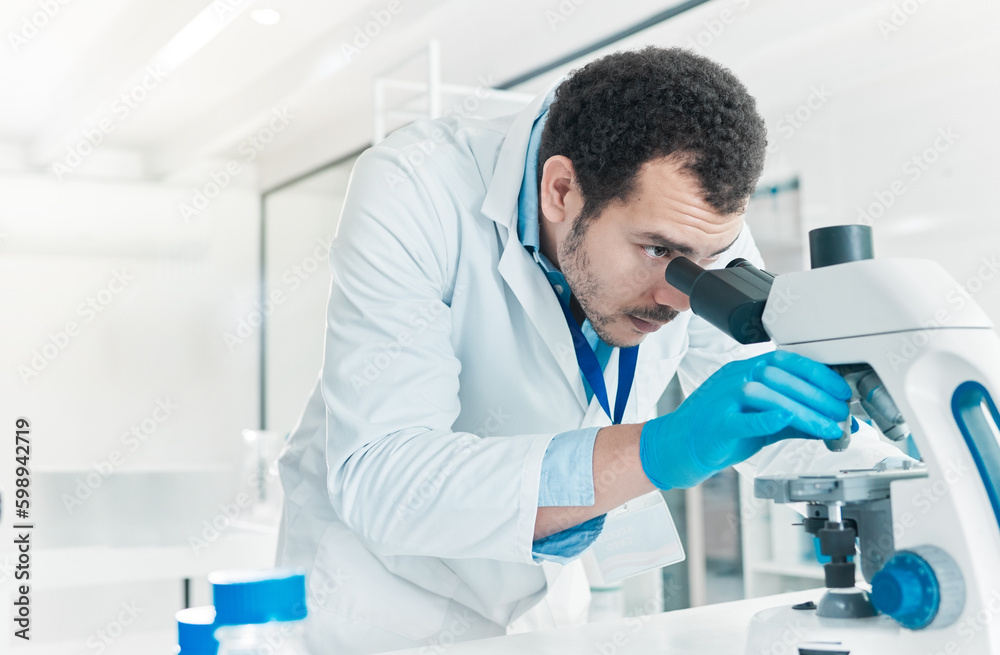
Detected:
[{"left": 538, "top": 46, "right": 767, "bottom": 221}]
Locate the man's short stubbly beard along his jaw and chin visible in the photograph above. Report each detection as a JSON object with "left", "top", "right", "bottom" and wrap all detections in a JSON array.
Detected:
[{"left": 558, "top": 214, "right": 680, "bottom": 348}]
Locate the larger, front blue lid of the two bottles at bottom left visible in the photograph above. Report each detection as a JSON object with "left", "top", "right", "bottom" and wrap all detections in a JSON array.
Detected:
[{"left": 208, "top": 569, "right": 306, "bottom": 627}]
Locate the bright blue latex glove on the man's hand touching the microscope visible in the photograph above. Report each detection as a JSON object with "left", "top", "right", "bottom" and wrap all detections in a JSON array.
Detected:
[{"left": 639, "top": 351, "right": 851, "bottom": 489}]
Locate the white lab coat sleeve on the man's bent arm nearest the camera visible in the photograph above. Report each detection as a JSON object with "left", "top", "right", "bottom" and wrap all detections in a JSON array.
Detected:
[{"left": 321, "top": 143, "right": 553, "bottom": 563}]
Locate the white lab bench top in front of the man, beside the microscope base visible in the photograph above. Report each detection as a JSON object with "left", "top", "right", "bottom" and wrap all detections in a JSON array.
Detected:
[{"left": 376, "top": 589, "right": 825, "bottom": 655}]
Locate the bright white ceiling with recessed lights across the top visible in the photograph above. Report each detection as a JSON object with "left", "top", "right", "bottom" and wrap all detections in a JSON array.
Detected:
[{"left": 0, "top": 0, "right": 1000, "bottom": 189}]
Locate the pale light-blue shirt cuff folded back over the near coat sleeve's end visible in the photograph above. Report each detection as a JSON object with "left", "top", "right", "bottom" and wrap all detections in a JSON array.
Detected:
[{"left": 538, "top": 427, "right": 601, "bottom": 507}]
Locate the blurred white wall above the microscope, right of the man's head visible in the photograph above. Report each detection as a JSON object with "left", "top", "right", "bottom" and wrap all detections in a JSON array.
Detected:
[{"left": 765, "top": 36, "right": 1000, "bottom": 325}]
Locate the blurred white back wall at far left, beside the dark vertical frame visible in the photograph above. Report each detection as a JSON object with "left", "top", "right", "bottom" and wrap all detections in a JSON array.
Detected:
[{"left": 0, "top": 176, "right": 259, "bottom": 469}]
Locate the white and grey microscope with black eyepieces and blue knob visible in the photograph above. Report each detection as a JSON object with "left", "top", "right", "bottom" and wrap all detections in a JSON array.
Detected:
[{"left": 666, "top": 225, "right": 1000, "bottom": 655}]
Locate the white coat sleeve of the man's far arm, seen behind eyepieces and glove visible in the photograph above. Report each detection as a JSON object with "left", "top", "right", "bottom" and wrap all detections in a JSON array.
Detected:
[{"left": 677, "top": 227, "right": 901, "bottom": 477}]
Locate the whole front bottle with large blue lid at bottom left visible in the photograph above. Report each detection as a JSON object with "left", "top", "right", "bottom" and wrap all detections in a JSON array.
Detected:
[{"left": 208, "top": 569, "right": 309, "bottom": 655}]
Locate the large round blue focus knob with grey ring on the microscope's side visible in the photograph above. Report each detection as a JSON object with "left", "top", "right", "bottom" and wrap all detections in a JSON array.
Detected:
[{"left": 871, "top": 546, "right": 965, "bottom": 630}]
